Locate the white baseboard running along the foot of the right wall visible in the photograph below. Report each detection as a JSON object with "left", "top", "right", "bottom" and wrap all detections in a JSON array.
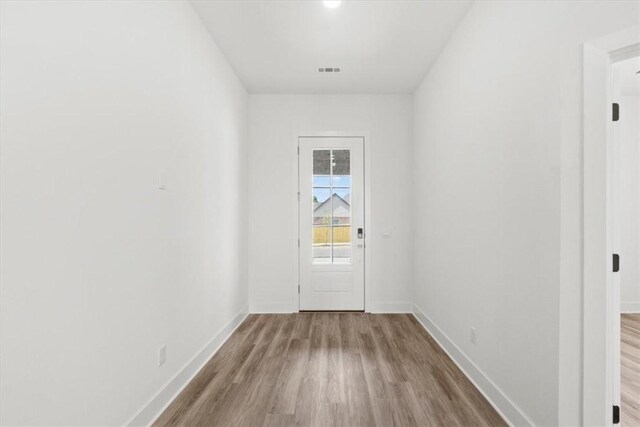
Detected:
[{"left": 413, "top": 305, "right": 534, "bottom": 426}]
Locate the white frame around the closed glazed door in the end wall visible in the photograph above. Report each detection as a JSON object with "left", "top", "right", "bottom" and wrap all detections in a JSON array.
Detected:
[{"left": 291, "top": 131, "right": 373, "bottom": 313}]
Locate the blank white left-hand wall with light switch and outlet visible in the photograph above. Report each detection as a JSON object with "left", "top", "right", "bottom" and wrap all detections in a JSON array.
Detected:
[{"left": 0, "top": 1, "right": 248, "bottom": 425}]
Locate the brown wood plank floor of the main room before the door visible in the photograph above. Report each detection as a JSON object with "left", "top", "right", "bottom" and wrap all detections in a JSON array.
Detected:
[{"left": 154, "top": 313, "right": 506, "bottom": 427}]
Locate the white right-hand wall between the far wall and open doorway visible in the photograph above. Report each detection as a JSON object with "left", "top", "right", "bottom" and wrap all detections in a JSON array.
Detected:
[{"left": 413, "top": 1, "right": 638, "bottom": 425}]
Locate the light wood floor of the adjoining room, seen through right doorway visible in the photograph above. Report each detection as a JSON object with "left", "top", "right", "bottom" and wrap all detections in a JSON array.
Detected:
[{"left": 620, "top": 314, "right": 640, "bottom": 427}]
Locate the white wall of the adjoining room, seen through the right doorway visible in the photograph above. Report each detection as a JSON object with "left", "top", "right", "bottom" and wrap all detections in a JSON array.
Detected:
[{"left": 614, "top": 96, "right": 640, "bottom": 312}]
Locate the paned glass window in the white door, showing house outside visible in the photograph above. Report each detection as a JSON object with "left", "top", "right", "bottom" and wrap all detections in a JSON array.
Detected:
[{"left": 313, "top": 149, "right": 351, "bottom": 264}]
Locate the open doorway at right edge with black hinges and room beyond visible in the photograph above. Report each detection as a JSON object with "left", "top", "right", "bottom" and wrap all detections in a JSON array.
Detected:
[{"left": 611, "top": 56, "right": 640, "bottom": 425}]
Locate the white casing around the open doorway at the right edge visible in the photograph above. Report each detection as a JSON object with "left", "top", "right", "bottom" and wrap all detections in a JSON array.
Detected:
[{"left": 582, "top": 27, "right": 640, "bottom": 426}]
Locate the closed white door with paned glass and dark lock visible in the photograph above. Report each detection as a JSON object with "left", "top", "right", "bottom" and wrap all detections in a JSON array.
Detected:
[{"left": 298, "top": 137, "right": 365, "bottom": 310}]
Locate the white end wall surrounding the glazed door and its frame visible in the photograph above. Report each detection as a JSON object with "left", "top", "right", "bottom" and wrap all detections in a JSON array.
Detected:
[{"left": 249, "top": 95, "right": 413, "bottom": 312}]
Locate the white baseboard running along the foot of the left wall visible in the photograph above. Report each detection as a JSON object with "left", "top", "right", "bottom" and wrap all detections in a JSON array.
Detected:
[{"left": 126, "top": 307, "right": 248, "bottom": 426}]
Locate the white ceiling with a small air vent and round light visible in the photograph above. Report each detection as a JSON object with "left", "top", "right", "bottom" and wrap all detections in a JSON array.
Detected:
[{"left": 191, "top": 0, "right": 471, "bottom": 93}]
